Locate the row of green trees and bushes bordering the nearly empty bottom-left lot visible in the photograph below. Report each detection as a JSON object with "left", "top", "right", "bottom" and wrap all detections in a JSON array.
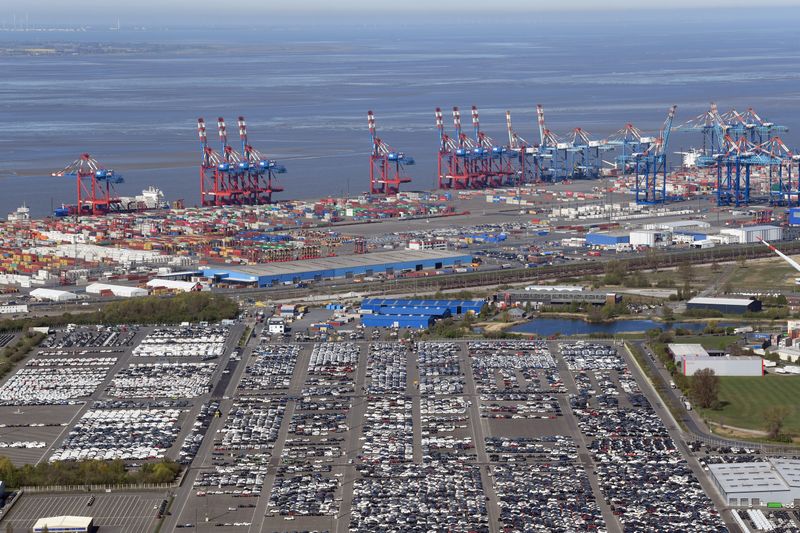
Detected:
[{"left": 0, "top": 456, "right": 181, "bottom": 487}]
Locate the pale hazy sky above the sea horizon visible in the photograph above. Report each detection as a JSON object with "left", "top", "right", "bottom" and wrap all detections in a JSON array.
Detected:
[{"left": 9, "top": 0, "right": 800, "bottom": 25}]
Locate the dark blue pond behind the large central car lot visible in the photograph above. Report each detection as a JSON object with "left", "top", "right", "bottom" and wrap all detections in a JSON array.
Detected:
[{"left": 509, "top": 318, "right": 736, "bottom": 337}]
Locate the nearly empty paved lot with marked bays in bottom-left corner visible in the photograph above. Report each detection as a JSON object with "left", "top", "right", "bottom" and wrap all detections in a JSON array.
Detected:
[{"left": 2, "top": 492, "right": 164, "bottom": 533}]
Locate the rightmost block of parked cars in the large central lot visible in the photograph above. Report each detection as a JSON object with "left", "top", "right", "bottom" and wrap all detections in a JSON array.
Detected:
[{"left": 560, "top": 343, "right": 727, "bottom": 532}]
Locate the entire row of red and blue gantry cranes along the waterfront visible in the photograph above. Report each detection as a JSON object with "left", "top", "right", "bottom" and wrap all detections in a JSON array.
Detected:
[{"left": 45, "top": 102, "right": 800, "bottom": 215}]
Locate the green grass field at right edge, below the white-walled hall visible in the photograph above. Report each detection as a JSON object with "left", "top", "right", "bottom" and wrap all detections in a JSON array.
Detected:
[{"left": 702, "top": 376, "right": 800, "bottom": 435}]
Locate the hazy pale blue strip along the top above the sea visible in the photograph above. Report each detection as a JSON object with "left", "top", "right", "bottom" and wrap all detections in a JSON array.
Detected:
[{"left": 0, "top": 0, "right": 800, "bottom": 29}]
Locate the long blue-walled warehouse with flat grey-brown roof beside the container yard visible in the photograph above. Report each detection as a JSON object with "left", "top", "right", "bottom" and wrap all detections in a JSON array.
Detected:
[{"left": 203, "top": 250, "right": 472, "bottom": 287}]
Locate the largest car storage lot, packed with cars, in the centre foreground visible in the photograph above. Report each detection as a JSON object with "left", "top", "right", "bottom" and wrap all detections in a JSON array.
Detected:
[{"left": 173, "top": 341, "right": 723, "bottom": 532}]
